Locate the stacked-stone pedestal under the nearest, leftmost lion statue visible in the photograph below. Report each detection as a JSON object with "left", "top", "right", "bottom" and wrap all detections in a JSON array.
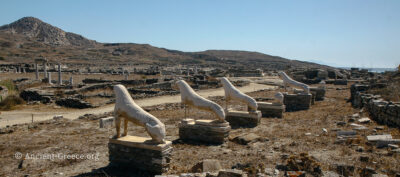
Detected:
[{"left": 108, "top": 135, "right": 172, "bottom": 174}]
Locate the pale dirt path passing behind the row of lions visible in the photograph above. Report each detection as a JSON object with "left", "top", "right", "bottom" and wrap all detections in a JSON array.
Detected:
[{"left": 0, "top": 83, "right": 275, "bottom": 127}]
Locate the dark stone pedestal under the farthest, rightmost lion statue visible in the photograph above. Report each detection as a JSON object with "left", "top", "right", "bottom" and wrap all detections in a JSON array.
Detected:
[{"left": 283, "top": 93, "right": 312, "bottom": 112}]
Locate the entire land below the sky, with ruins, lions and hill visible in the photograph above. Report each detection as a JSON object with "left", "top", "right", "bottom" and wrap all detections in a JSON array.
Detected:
[{"left": 0, "top": 5, "right": 400, "bottom": 177}]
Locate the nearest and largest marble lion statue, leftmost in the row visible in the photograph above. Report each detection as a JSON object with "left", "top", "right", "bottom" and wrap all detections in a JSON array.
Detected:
[{"left": 114, "top": 84, "right": 165, "bottom": 143}]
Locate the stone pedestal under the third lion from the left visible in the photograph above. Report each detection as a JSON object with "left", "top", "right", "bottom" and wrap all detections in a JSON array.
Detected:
[{"left": 225, "top": 110, "right": 261, "bottom": 128}]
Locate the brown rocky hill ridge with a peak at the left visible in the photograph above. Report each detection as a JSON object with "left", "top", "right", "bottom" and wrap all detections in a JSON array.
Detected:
[{"left": 0, "top": 17, "right": 324, "bottom": 69}]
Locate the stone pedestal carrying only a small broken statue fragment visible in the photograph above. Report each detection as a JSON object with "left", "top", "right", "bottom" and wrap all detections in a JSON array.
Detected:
[{"left": 257, "top": 102, "right": 285, "bottom": 118}]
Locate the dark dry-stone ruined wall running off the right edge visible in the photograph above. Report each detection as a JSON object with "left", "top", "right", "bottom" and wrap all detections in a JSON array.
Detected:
[{"left": 350, "top": 84, "right": 400, "bottom": 128}]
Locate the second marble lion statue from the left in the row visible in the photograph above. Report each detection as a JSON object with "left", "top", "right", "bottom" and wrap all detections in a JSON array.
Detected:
[{"left": 176, "top": 80, "right": 225, "bottom": 122}]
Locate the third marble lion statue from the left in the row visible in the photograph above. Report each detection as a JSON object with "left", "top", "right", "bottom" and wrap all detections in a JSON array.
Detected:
[{"left": 221, "top": 77, "right": 258, "bottom": 111}]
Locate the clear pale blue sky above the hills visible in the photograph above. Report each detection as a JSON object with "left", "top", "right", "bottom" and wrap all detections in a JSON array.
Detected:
[{"left": 0, "top": 0, "right": 400, "bottom": 67}]
